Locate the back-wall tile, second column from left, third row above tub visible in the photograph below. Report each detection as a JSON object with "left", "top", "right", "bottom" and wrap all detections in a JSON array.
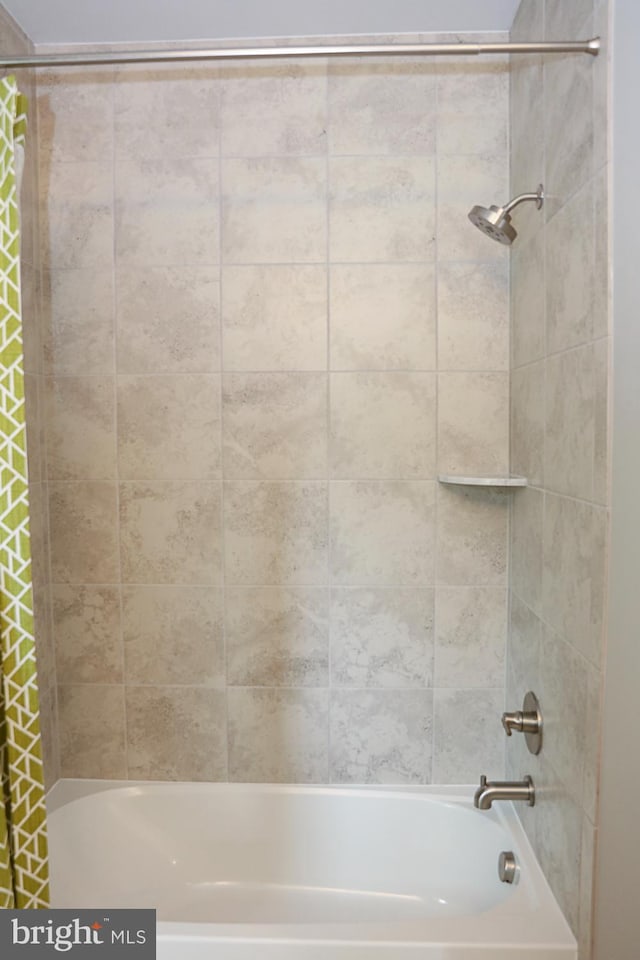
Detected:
[{"left": 120, "top": 481, "right": 222, "bottom": 584}]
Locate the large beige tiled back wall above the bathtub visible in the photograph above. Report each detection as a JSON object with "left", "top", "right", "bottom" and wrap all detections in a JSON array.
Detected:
[{"left": 39, "top": 39, "right": 509, "bottom": 783}]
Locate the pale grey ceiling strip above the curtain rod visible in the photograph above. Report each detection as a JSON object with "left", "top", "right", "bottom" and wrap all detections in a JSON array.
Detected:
[{"left": 2, "top": 0, "right": 520, "bottom": 44}]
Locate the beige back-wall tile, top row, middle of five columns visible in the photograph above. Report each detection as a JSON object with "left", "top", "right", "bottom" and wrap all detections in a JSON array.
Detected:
[{"left": 221, "top": 59, "right": 327, "bottom": 157}]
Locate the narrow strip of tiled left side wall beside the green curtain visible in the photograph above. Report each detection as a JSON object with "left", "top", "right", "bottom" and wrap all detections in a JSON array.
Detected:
[{"left": 0, "top": 5, "right": 59, "bottom": 786}]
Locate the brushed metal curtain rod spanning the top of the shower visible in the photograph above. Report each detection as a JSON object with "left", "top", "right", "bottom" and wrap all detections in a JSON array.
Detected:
[{"left": 0, "top": 37, "right": 600, "bottom": 70}]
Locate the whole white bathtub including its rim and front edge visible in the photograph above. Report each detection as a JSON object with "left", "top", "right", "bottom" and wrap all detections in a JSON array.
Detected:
[{"left": 49, "top": 780, "right": 577, "bottom": 960}]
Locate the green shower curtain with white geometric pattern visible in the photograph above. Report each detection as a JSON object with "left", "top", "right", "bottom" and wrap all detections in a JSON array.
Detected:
[{"left": 0, "top": 77, "right": 49, "bottom": 909}]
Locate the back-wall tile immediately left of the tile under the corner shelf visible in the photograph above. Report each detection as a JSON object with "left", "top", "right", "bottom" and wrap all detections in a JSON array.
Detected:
[{"left": 331, "top": 480, "right": 435, "bottom": 586}]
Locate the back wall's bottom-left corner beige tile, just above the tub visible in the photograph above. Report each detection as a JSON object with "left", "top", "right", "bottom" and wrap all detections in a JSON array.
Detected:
[{"left": 58, "top": 683, "right": 127, "bottom": 780}]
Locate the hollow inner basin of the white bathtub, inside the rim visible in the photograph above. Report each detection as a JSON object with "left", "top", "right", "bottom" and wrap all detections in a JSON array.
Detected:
[{"left": 50, "top": 784, "right": 514, "bottom": 924}]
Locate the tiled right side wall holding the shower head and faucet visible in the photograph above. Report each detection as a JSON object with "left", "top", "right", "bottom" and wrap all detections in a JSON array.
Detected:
[{"left": 507, "top": 0, "right": 610, "bottom": 960}]
